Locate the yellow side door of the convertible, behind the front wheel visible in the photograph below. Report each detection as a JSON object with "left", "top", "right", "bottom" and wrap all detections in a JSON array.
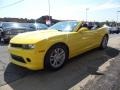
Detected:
[{"left": 68, "top": 29, "right": 97, "bottom": 56}]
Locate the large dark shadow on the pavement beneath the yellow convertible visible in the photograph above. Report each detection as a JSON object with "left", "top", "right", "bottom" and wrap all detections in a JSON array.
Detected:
[{"left": 4, "top": 47, "right": 120, "bottom": 90}]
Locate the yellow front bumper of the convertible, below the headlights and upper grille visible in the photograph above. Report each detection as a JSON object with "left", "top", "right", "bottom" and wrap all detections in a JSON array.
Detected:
[{"left": 8, "top": 46, "right": 44, "bottom": 70}]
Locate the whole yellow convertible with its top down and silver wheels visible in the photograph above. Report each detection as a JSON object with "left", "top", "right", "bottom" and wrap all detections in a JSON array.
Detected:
[{"left": 8, "top": 21, "right": 108, "bottom": 70}]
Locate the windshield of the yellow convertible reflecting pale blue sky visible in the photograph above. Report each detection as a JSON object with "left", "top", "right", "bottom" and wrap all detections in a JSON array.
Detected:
[{"left": 48, "top": 21, "right": 78, "bottom": 32}]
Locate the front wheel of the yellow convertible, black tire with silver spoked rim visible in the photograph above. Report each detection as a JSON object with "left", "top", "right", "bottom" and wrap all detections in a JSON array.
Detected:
[{"left": 44, "top": 44, "right": 69, "bottom": 70}]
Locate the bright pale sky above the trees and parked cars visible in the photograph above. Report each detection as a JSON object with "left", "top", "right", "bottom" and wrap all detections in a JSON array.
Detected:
[{"left": 0, "top": 0, "right": 120, "bottom": 21}]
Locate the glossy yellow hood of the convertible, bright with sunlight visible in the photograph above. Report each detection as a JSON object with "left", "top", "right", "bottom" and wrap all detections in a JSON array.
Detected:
[{"left": 10, "top": 30, "right": 69, "bottom": 44}]
